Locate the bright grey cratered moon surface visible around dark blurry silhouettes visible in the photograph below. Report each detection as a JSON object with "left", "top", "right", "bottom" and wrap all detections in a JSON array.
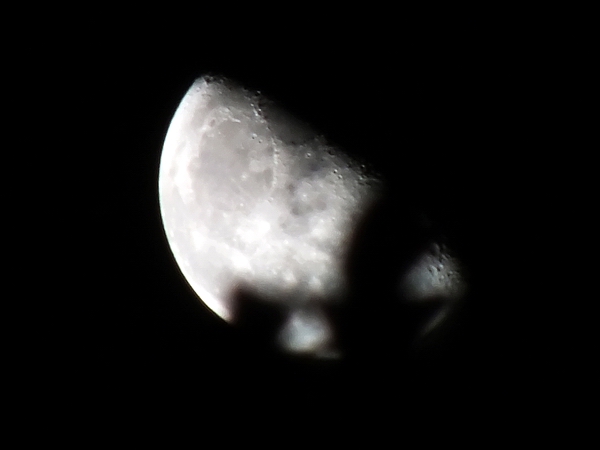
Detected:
[{"left": 159, "top": 77, "right": 463, "bottom": 357}]
